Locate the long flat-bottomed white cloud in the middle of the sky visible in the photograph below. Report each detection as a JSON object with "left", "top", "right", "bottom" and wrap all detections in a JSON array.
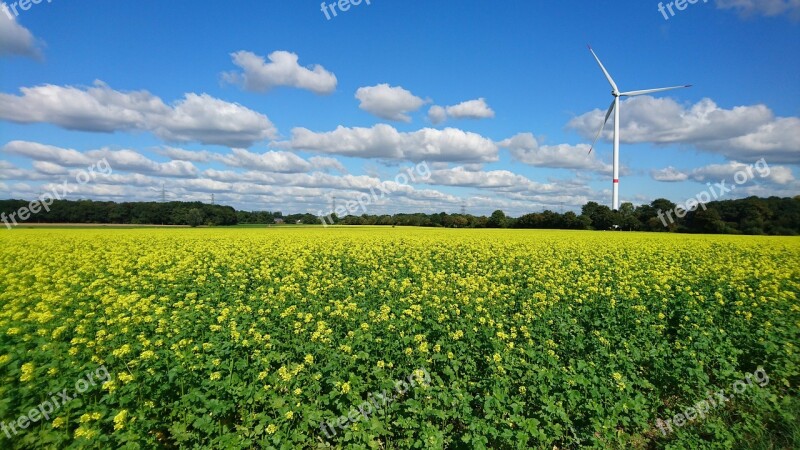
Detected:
[{"left": 275, "top": 124, "right": 497, "bottom": 162}]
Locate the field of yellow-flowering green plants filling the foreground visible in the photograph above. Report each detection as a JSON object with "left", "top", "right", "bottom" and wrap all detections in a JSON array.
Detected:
[{"left": 0, "top": 227, "right": 800, "bottom": 449}]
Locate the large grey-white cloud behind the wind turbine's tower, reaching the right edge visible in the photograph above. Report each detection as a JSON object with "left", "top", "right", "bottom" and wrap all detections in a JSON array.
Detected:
[{"left": 568, "top": 96, "right": 800, "bottom": 164}]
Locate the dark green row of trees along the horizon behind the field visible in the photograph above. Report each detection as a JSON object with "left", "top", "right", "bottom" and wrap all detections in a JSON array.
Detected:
[{"left": 0, "top": 196, "right": 800, "bottom": 235}]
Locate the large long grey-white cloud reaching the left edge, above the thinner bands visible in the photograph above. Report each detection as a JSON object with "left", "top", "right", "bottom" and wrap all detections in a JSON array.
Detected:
[{"left": 0, "top": 81, "right": 277, "bottom": 147}]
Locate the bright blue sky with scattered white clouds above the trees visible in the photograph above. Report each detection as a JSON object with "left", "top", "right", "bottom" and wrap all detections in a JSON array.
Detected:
[{"left": 0, "top": 0, "right": 800, "bottom": 215}]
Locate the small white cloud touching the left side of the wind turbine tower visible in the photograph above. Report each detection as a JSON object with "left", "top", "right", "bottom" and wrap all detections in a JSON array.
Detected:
[{"left": 498, "top": 133, "right": 612, "bottom": 174}]
